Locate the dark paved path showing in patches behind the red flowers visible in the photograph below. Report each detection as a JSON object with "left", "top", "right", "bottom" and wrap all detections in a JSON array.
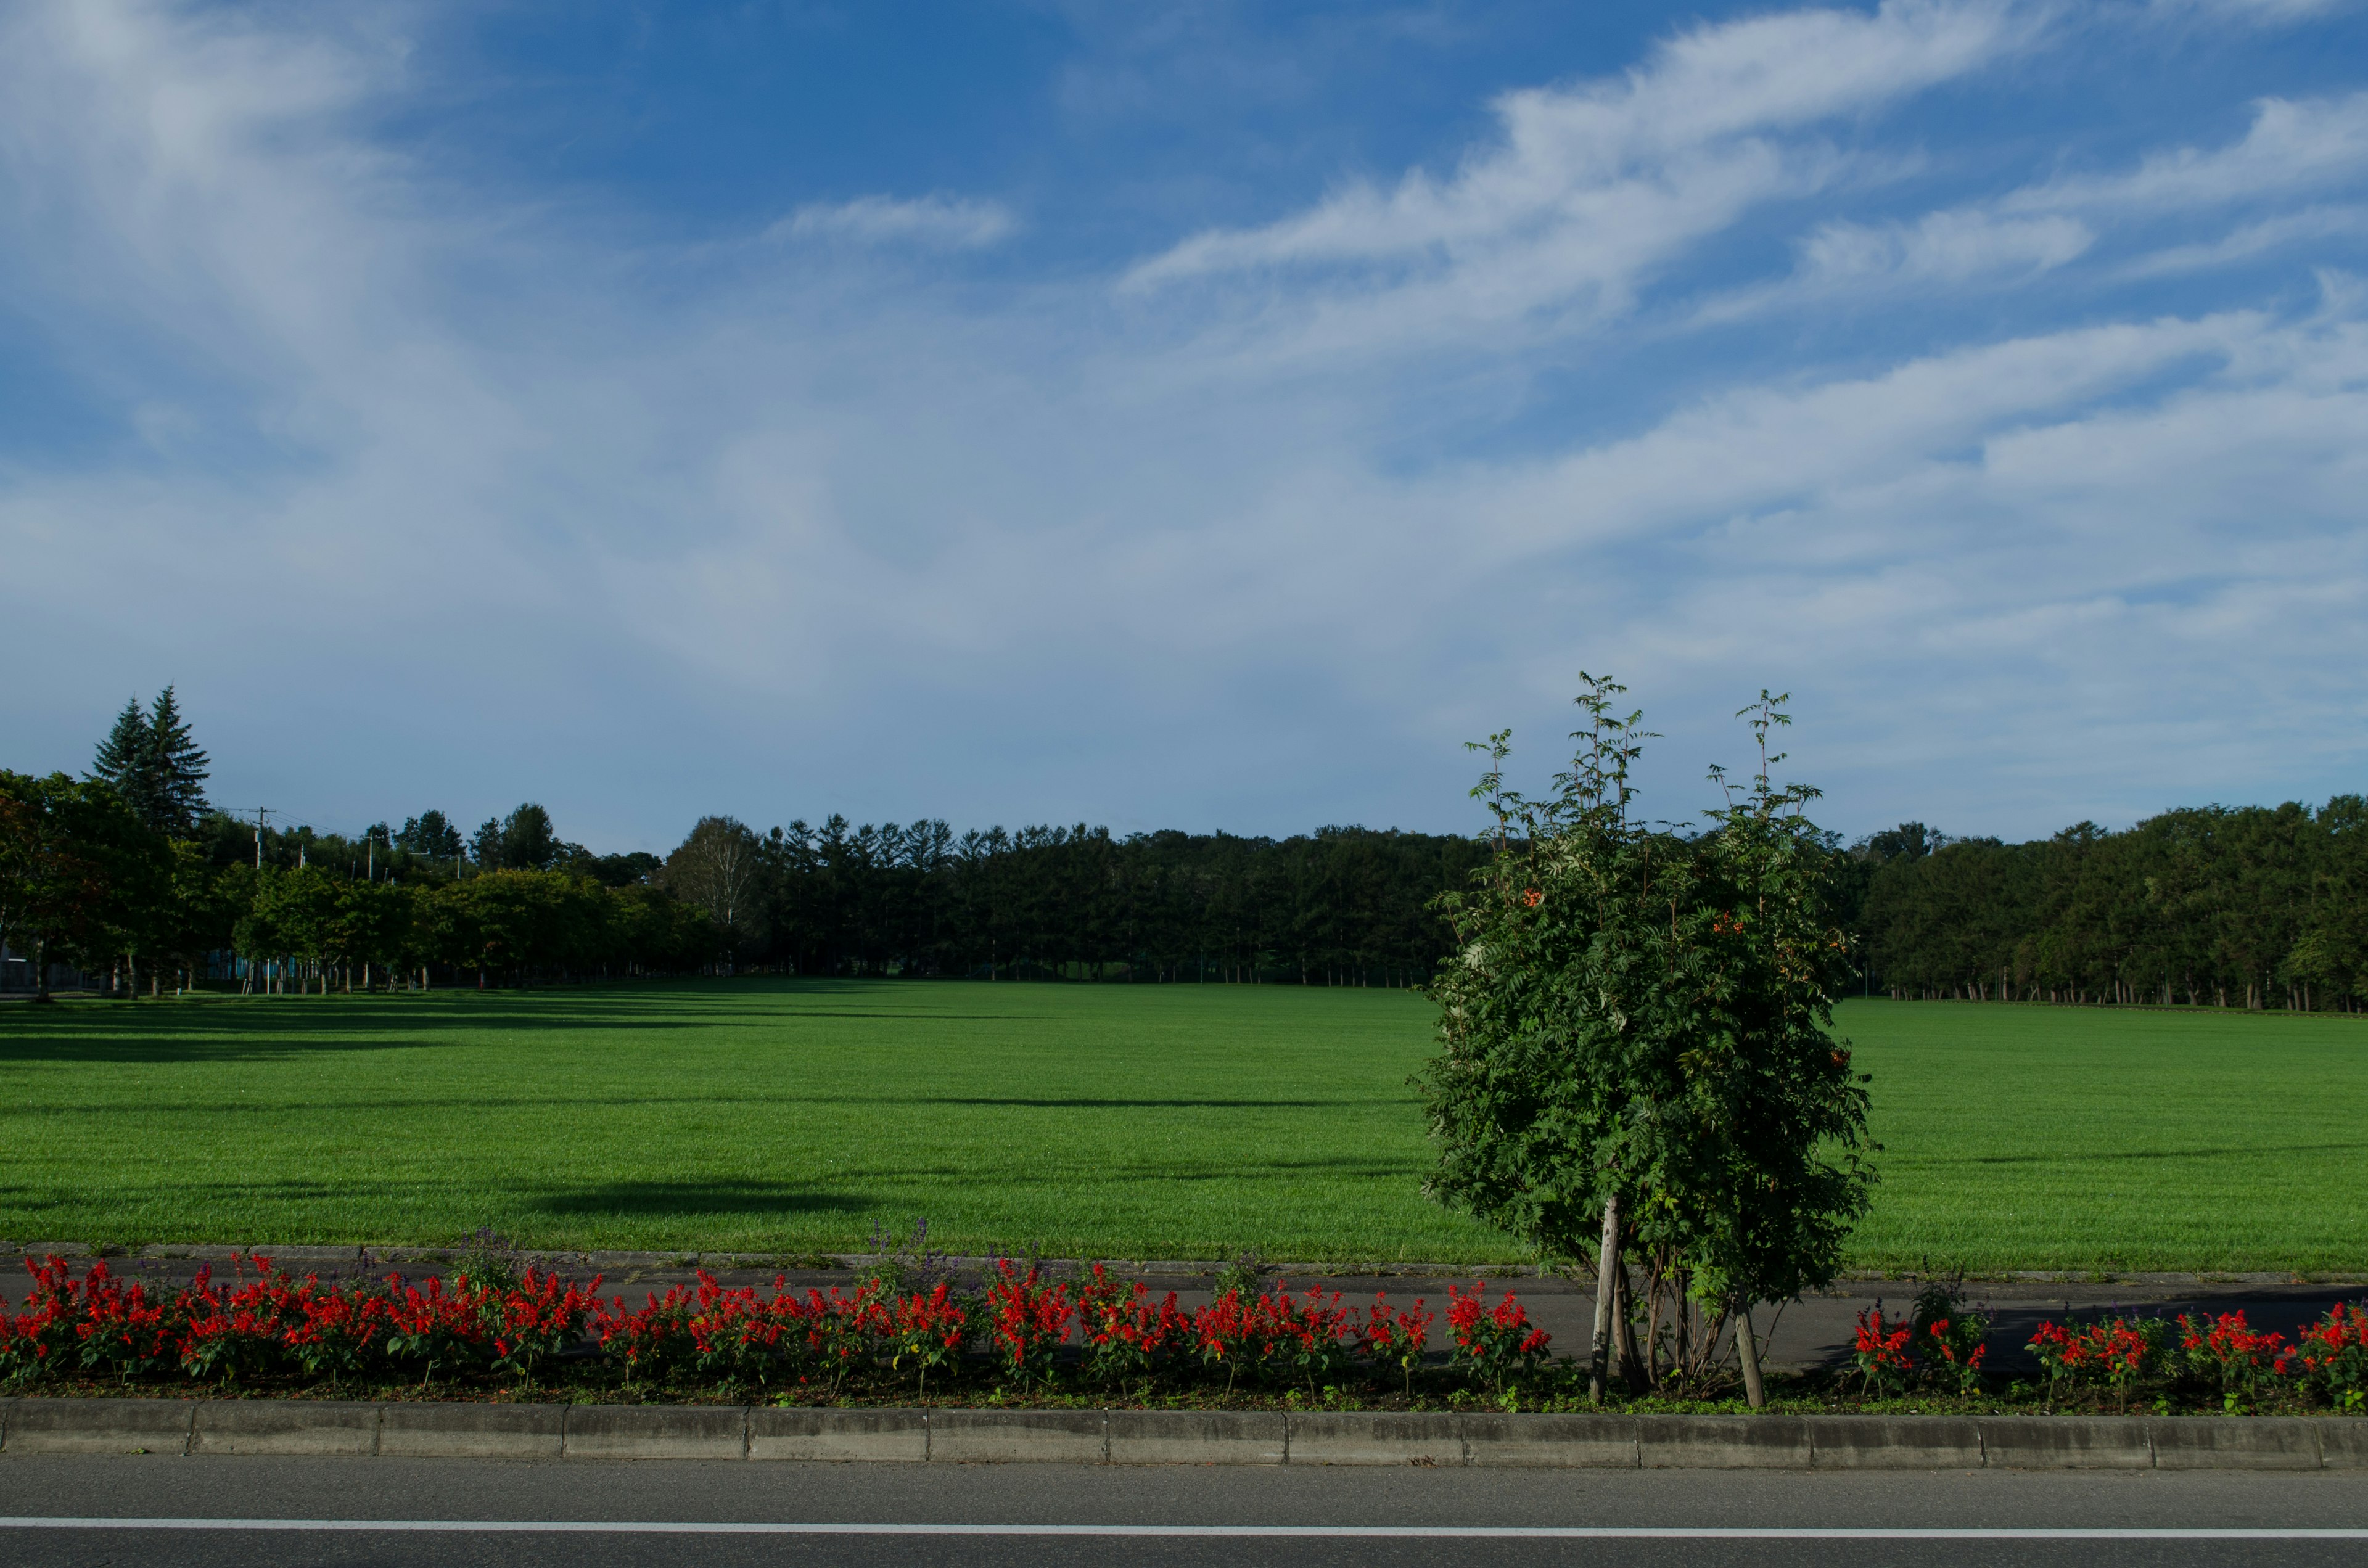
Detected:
[{"left": 0, "top": 1248, "right": 2368, "bottom": 1371}]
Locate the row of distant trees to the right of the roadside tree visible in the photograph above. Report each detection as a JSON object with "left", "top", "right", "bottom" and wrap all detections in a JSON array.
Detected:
[{"left": 1852, "top": 796, "right": 2368, "bottom": 1011}]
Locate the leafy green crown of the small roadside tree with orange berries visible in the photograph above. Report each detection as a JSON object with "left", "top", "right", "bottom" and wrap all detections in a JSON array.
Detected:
[{"left": 1418, "top": 678, "right": 1873, "bottom": 1300}]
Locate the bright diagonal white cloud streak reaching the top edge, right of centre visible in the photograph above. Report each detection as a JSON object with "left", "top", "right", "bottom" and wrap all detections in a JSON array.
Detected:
[{"left": 1125, "top": 0, "right": 2034, "bottom": 343}]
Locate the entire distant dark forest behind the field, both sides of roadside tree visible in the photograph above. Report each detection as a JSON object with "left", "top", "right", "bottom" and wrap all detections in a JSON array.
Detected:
[{"left": 0, "top": 689, "right": 2368, "bottom": 1011}]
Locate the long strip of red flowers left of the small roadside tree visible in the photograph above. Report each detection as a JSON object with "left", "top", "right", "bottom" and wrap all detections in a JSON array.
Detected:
[{"left": 0, "top": 1255, "right": 1547, "bottom": 1397}]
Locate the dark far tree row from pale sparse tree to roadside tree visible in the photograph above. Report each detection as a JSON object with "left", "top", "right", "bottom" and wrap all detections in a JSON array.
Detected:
[{"left": 656, "top": 817, "right": 1487, "bottom": 985}]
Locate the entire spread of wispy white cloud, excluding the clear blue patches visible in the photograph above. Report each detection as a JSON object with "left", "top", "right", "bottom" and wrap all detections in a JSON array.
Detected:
[{"left": 0, "top": 2, "right": 2368, "bottom": 841}]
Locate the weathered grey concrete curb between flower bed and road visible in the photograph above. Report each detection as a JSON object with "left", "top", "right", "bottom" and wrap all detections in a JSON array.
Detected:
[{"left": 0, "top": 1400, "right": 2368, "bottom": 1471}]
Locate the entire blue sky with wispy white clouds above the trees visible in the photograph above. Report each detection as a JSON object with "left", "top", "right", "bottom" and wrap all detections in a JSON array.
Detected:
[{"left": 0, "top": 0, "right": 2368, "bottom": 850}]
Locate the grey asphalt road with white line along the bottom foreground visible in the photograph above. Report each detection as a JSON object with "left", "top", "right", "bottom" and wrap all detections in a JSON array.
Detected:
[{"left": 0, "top": 1456, "right": 2368, "bottom": 1568}]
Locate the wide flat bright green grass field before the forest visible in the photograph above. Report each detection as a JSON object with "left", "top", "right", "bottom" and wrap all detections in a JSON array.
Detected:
[{"left": 0, "top": 980, "right": 2368, "bottom": 1272}]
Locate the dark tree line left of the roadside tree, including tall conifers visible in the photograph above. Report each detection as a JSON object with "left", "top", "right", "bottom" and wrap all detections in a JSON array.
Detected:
[{"left": 0, "top": 687, "right": 1485, "bottom": 993}]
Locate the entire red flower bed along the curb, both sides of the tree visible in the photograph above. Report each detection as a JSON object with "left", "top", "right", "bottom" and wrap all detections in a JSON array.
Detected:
[{"left": 0, "top": 1255, "right": 2368, "bottom": 1414}]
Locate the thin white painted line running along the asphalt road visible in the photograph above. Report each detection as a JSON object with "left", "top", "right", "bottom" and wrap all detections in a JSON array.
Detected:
[{"left": 0, "top": 1516, "right": 2368, "bottom": 1542}]
